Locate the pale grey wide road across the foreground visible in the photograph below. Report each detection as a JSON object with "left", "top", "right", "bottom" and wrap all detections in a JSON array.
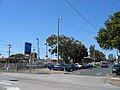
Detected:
[{"left": 0, "top": 73, "right": 120, "bottom": 90}]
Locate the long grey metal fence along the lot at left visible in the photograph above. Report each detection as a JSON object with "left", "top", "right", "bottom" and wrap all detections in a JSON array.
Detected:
[{"left": 0, "top": 62, "right": 44, "bottom": 72}]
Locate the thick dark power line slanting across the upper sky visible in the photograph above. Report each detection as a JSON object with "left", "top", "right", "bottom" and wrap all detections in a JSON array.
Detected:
[{"left": 65, "top": 0, "right": 98, "bottom": 30}]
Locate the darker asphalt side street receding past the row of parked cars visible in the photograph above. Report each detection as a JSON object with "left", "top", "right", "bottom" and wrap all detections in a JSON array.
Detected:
[{"left": 72, "top": 64, "right": 113, "bottom": 76}]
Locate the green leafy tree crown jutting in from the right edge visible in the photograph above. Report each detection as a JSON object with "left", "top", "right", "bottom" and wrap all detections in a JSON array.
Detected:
[{"left": 96, "top": 11, "right": 120, "bottom": 51}]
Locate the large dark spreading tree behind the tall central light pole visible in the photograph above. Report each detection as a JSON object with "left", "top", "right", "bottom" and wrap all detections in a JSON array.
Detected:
[{"left": 46, "top": 35, "right": 88, "bottom": 63}]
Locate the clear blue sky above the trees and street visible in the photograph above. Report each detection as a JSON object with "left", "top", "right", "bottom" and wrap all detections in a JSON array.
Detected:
[{"left": 0, "top": 0, "right": 120, "bottom": 58}]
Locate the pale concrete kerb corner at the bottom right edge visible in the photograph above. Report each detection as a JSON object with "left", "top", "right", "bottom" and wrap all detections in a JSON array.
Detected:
[{"left": 107, "top": 74, "right": 120, "bottom": 87}]
